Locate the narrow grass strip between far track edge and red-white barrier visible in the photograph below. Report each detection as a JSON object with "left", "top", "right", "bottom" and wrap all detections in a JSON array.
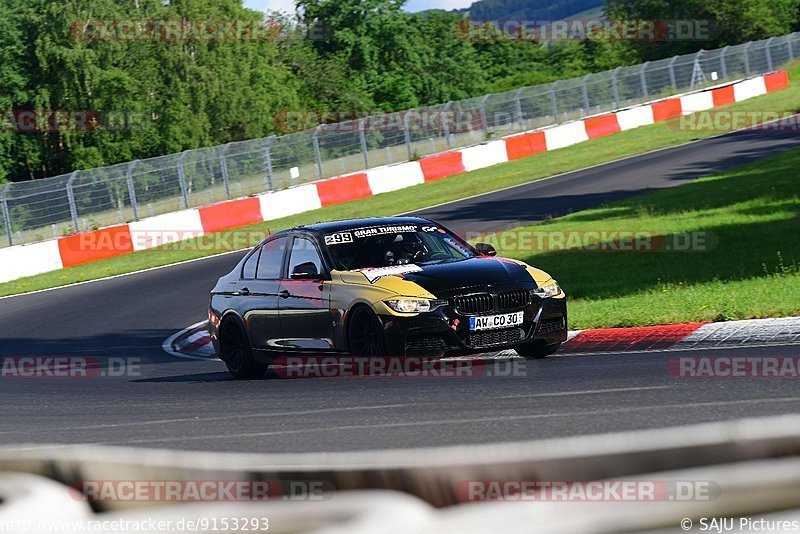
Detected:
[{"left": 0, "top": 63, "right": 800, "bottom": 302}]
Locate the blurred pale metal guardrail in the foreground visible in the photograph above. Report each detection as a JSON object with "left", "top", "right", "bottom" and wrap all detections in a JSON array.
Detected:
[{"left": 0, "top": 415, "right": 800, "bottom": 534}]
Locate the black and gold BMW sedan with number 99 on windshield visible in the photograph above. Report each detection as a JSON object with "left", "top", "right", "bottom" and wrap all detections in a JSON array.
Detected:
[{"left": 209, "top": 217, "right": 567, "bottom": 378}]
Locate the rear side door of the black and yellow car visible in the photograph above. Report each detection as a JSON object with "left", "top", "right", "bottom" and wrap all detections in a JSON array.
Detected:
[{"left": 239, "top": 237, "right": 289, "bottom": 350}]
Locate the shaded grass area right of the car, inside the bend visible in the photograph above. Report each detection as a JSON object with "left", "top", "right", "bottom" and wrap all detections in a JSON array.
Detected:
[{"left": 489, "top": 150, "right": 800, "bottom": 328}]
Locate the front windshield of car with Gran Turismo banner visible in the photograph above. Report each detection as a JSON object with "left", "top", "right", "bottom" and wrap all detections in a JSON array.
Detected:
[{"left": 325, "top": 225, "right": 475, "bottom": 271}]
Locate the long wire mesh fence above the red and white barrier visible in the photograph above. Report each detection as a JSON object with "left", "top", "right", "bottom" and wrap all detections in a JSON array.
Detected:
[{"left": 0, "top": 33, "right": 800, "bottom": 246}]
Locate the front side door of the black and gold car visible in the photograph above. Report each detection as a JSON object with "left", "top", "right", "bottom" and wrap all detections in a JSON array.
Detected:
[{"left": 279, "top": 234, "right": 334, "bottom": 351}]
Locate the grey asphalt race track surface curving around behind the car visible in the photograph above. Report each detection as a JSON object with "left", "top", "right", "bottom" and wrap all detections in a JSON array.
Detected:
[{"left": 0, "top": 127, "right": 800, "bottom": 452}]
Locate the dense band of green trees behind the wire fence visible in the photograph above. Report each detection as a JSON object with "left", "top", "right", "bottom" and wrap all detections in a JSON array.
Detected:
[{"left": 0, "top": 0, "right": 800, "bottom": 182}]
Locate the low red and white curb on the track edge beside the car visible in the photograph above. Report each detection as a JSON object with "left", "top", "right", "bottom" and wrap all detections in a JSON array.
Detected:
[{"left": 163, "top": 317, "right": 800, "bottom": 360}]
